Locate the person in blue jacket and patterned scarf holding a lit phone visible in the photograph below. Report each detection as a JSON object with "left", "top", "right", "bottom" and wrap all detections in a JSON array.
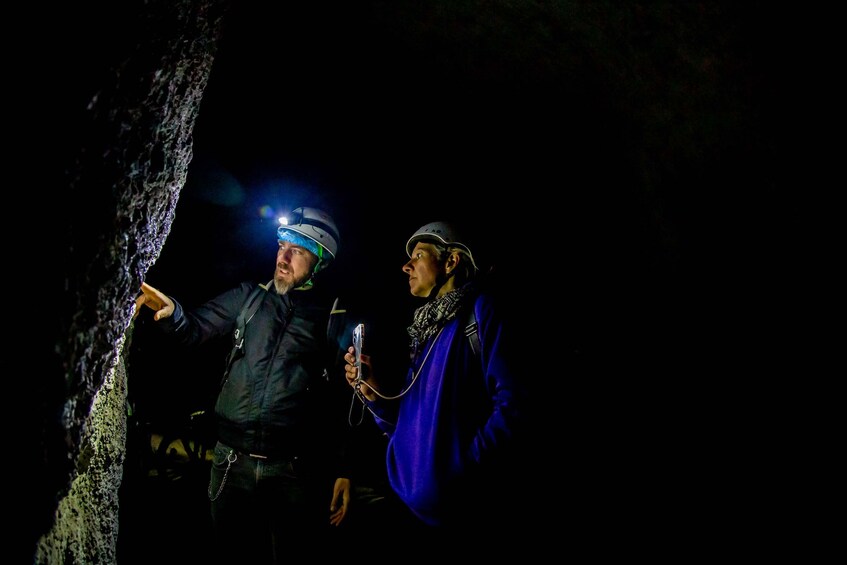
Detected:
[{"left": 345, "top": 218, "right": 525, "bottom": 532}]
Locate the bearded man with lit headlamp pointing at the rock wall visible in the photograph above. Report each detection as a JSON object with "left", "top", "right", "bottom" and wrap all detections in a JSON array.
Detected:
[{"left": 136, "top": 208, "right": 350, "bottom": 563}]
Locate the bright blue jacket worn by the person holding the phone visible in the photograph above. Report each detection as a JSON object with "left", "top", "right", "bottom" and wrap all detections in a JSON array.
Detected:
[{"left": 368, "top": 288, "right": 524, "bottom": 526}]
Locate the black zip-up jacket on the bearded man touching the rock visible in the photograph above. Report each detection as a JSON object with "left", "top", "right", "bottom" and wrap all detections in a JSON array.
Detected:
[{"left": 160, "top": 283, "right": 347, "bottom": 472}]
